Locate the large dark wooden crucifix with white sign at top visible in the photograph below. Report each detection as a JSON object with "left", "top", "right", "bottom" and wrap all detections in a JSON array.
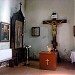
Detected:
[{"left": 43, "top": 12, "right": 67, "bottom": 51}]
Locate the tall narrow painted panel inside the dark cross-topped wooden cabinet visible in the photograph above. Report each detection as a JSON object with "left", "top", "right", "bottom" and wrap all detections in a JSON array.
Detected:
[{"left": 15, "top": 20, "right": 22, "bottom": 48}]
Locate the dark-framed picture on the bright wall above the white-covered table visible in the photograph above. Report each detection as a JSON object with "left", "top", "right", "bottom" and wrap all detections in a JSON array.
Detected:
[{"left": 0, "top": 22, "right": 10, "bottom": 42}]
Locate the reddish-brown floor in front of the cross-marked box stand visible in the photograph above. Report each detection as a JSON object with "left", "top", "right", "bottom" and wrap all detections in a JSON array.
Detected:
[{"left": 0, "top": 61, "right": 75, "bottom": 75}]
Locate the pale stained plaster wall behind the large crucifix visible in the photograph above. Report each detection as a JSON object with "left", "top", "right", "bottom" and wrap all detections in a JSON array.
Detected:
[{"left": 24, "top": 0, "right": 74, "bottom": 58}]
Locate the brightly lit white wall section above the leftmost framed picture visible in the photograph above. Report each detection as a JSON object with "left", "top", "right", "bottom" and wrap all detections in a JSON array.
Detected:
[{"left": 0, "top": 0, "right": 10, "bottom": 23}]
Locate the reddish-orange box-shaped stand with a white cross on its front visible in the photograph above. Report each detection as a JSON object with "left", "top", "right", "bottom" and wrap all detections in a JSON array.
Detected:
[{"left": 39, "top": 51, "right": 57, "bottom": 70}]
